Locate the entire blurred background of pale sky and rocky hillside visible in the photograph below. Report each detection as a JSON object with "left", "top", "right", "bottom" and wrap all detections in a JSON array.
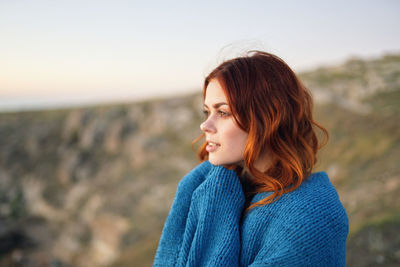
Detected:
[{"left": 0, "top": 0, "right": 400, "bottom": 266}]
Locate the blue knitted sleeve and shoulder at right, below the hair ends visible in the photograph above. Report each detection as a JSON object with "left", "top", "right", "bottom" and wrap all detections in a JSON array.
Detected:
[{"left": 242, "top": 176, "right": 349, "bottom": 267}]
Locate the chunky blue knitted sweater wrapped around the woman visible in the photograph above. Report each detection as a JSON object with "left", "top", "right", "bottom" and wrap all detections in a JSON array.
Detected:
[{"left": 153, "top": 161, "right": 348, "bottom": 267}]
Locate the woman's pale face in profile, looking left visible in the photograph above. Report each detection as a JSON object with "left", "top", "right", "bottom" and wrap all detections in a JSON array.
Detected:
[{"left": 200, "top": 79, "right": 248, "bottom": 165}]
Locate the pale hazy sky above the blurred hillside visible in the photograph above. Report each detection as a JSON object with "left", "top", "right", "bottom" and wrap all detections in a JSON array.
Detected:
[{"left": 0, "top": 0, "right": 400, "bottom": 111}]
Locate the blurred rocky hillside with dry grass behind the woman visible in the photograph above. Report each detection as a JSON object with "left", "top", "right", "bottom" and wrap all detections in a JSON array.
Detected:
[{"left": 0, "top": 55, "right": 400, "bottom": 266}]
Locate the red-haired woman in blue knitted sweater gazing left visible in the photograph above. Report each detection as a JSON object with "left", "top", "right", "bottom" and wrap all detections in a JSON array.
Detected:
[{"left": 154, "top": 51, "right": 348, "bottom": 266}]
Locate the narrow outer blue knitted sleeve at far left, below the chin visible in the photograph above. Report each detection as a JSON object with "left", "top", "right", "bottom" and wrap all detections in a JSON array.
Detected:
[{"left": 153, "top": 161, "right": 211, "bottom": 267}]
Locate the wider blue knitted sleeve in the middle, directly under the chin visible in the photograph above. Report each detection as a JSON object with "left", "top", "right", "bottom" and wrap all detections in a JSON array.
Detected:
[{"left": 178, "top": 165, "right": 245, "bottom": 266}]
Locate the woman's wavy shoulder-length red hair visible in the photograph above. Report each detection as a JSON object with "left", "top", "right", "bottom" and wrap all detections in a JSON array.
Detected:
[{"left": 194, "top": 51, "right": 329, "bottom": 214}]
